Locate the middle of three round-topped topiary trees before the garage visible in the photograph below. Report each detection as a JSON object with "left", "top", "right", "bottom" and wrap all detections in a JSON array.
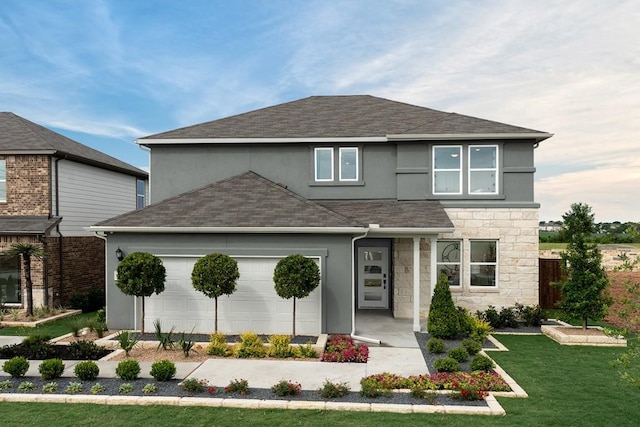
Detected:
[{"left": 191, "top": 253, "right": 240, "bottom": 333}]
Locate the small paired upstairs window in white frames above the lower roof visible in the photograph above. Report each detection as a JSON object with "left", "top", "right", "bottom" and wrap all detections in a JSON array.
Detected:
[{"left": 313, "top": 147, "right": 360, "bottom": 183}]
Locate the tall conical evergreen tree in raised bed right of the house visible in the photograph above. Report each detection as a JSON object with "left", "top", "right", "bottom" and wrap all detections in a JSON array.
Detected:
[{"left": 558, "top": 203, "right": 612, "bottom": 329}]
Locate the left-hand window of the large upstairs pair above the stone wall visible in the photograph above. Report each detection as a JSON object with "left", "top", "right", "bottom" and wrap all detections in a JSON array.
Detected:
[{"left": 433, "top": 146, "right": 462, "bottom": 194}]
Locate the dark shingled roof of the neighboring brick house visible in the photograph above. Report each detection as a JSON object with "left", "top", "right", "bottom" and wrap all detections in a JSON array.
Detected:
[{"left": 0, "top": 112, "right": 148, "bottom": 178}]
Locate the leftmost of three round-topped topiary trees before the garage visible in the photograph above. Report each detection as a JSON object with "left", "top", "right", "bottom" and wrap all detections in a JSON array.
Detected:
[{"left": 116, "top": 252, "right": 167, "bottom": 333}]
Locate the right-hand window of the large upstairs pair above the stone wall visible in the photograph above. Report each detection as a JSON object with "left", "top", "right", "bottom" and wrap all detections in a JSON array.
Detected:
[{"left": 469, "top": 145, "right": 498, "bottom": 194}]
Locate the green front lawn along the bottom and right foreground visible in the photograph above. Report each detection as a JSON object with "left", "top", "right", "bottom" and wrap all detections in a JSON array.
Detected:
[{"left": 1, "top": 335, "right": 640, "bottom": 427}]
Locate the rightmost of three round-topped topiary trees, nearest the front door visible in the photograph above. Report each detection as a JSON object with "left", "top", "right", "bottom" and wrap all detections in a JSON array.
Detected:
[{"left": 273, "top": 255, "right": 320, "bottom": 337}]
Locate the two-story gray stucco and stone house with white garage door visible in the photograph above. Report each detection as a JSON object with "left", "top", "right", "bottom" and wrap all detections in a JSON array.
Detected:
[{"left": 90, "top": 96, "right": 551, "bottom": 334}]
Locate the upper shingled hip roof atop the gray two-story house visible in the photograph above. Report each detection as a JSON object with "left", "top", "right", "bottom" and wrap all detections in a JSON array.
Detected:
[{"left": 138, "top": 95, "right": 550, "bottom": 140}]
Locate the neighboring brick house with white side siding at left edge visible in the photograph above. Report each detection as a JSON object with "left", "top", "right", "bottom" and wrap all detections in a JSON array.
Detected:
[{"left": 0, "top": 112, "right": 148, "bottom": 307}]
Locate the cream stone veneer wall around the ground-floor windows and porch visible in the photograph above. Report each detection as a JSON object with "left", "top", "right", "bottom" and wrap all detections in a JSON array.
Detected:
[{"left": 393, "top": 208, "right": 538, "bottom": 318}]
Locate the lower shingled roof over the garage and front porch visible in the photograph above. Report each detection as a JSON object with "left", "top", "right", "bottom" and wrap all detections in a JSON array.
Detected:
[{"left": 91, "top": 171, "right": 453, "bottom": 232}]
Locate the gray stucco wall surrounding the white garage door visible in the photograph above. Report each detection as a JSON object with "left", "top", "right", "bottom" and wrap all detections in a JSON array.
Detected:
[{"left": 106, "top": 233, "right": 352, "bottom": 333}]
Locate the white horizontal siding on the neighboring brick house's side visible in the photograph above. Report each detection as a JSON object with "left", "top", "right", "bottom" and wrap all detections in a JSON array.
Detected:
[{"left": 53, "top": 160, "right": 136, "bottom": 236}]
